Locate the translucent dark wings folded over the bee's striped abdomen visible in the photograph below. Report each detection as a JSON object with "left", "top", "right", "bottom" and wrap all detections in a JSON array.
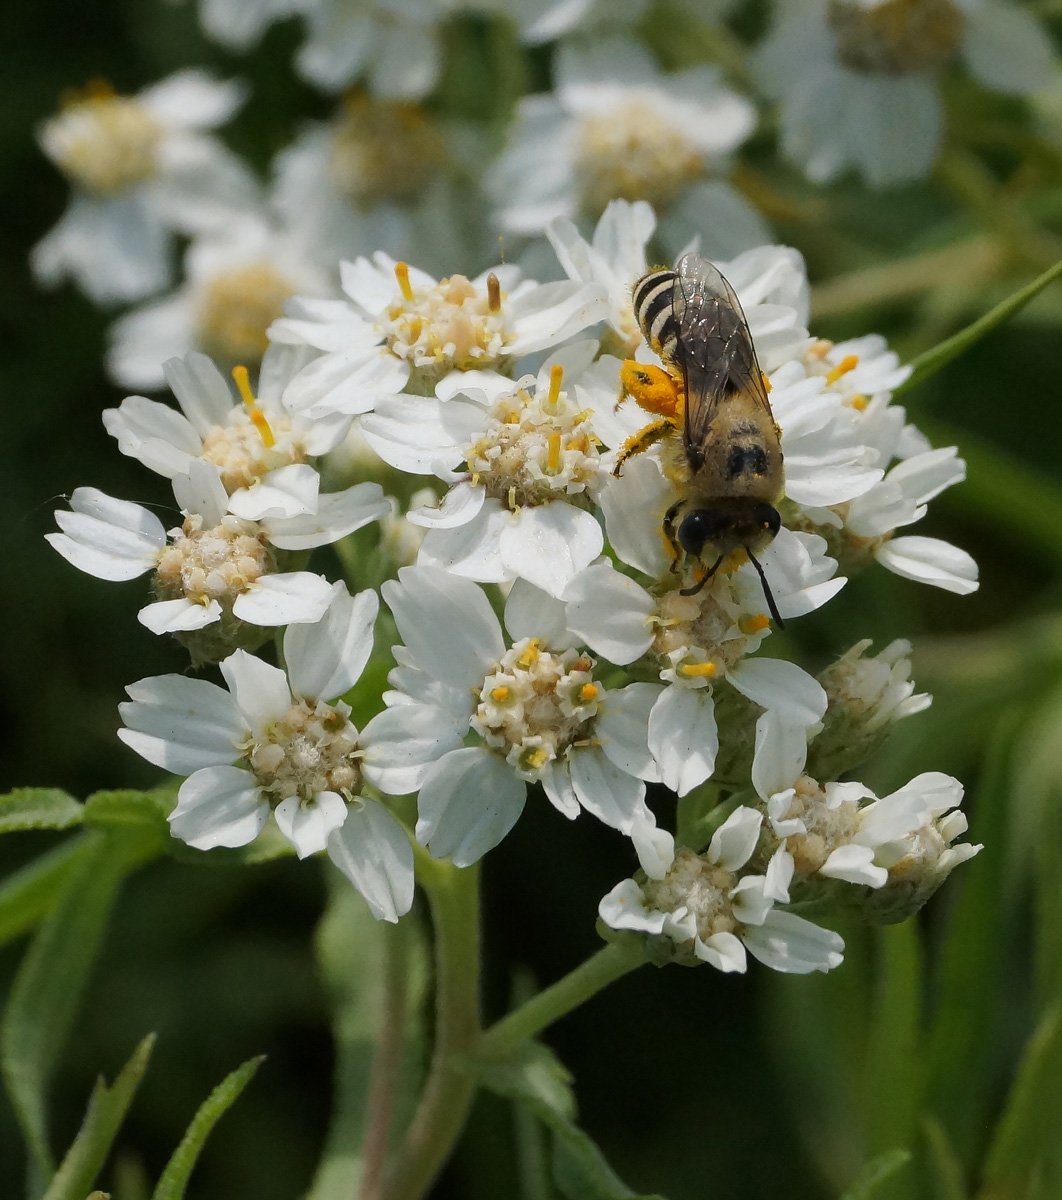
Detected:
[{"left": 672, "top": 254, "right": 770, "bottom": 468}]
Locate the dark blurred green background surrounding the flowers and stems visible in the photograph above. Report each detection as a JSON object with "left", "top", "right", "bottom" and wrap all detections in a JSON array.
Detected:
[{"left": 0, "top": 0, "right": 1062, "bottom": 1200}]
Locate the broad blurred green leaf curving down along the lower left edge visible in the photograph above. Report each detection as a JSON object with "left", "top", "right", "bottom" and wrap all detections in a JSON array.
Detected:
[{"left": 0, "top": 834, "right": 138, "bottom": 1194}]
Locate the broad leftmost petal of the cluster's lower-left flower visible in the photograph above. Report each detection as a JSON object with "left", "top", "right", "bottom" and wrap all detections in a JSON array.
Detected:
[{"left": 118, "top": 676, "right": 251, "bottom": 775}]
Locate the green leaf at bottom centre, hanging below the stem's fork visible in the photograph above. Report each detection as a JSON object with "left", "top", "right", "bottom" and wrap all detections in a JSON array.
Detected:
[{"left": 470, "top": 1042, "right": 660, "bottom": 1200}]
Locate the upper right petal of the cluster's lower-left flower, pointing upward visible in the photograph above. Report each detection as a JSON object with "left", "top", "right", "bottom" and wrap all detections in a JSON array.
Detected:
[{"left": 284, "top": 583, "right": 379, "bottom": 701}]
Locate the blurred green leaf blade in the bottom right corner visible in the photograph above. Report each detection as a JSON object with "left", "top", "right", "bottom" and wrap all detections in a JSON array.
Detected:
[{"left": 984, "top": 1006, "right": 1062, "bottom": 1196}]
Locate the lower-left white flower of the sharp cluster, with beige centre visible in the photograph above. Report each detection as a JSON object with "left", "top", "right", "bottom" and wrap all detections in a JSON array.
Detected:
[{"left": 118, "top": 583, "right": 413, "bottom": 922}]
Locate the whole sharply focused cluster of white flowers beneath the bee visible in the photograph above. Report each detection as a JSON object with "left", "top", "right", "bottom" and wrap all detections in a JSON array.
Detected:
[{"left": 49, "top": 194, "right": 978, "bottom": 972}]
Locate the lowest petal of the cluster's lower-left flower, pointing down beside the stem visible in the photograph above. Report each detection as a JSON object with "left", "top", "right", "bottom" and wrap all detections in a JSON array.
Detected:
[{"left": 328, "top": 800, "right": 414, "bottom": 922}]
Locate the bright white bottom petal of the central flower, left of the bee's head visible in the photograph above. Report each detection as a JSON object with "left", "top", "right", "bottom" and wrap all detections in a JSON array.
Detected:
[{"left": 500, "top": 500, "right": 605, "bottom": 596}]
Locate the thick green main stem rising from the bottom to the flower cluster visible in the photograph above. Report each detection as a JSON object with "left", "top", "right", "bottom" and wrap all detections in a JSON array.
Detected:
[{"left": 383, "top": 851, "right": 480, "bottom": 1200}]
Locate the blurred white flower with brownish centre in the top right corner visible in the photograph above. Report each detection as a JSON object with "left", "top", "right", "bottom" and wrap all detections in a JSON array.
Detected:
[{"left": 755, "top": 0, "right": 1057, "bottom": 187}]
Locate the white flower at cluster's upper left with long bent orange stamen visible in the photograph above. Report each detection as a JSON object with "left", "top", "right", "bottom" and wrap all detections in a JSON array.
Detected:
[{"left": 103, "top": 346, "right": 350, "bottom": 494}]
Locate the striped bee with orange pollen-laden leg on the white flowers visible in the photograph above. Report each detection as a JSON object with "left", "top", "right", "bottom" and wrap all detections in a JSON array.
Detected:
[{"left": 613, "top": 254, "right": 784, "bottom": 625}]
